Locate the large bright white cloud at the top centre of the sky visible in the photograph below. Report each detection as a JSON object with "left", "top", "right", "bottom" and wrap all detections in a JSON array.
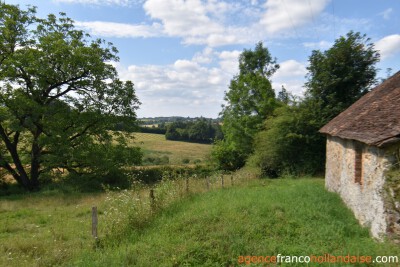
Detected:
[{"left": 143, "top": 0, "right": 272, "bottom": 47}]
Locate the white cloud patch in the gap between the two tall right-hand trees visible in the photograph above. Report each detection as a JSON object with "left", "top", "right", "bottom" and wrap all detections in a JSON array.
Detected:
[{"left": 271, "top": 60, "right": 307, "bottom": 96}]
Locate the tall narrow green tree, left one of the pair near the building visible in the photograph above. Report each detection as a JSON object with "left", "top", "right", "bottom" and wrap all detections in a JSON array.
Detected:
[{"left": 215, "top": 42, "right": 279, "bottom": 170}]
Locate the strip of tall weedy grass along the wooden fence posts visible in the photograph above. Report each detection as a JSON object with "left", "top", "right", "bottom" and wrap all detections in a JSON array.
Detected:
[{"left": 99, "top": 171, "right": 255, "bottom": 246}]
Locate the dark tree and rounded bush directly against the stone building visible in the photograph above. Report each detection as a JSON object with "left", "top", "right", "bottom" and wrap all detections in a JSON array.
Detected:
[{"left": 250, "top": 32, "right": 379, "bottom": 176}]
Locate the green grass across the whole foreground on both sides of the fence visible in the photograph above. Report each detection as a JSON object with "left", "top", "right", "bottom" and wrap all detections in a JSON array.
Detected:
[{"left": 0, "top": 179, "right": 400, "bottom": 266}]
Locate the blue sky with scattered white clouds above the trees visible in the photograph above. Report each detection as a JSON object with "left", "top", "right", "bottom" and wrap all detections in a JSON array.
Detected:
[{"left": 5, "top": 0, "right": 400, "bottom": 118}]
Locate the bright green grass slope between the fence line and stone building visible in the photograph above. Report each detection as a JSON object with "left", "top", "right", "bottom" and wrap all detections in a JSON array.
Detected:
[{"left": 67, "top": 179, "right": 400, "bottom": 266}]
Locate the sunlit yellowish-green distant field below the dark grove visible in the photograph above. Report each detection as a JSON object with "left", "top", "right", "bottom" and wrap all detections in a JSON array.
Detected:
[{"left": 133, "top": 133, "right": 212, "bottom": 165}]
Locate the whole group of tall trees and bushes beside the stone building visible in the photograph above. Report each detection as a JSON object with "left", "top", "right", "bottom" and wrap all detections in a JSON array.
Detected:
[{"left": 213, "top": 32, "right": 379, "bottom": 176}]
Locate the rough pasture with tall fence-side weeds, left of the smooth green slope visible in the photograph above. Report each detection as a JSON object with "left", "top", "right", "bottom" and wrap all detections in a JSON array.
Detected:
[{"left": 0, "top": 171, "right": 255, "bottom": 267}]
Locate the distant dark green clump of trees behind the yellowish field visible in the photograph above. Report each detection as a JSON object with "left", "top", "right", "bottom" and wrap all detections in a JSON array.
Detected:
[{"left": 165, "top": 118, "right": 223, "bottom": 144}]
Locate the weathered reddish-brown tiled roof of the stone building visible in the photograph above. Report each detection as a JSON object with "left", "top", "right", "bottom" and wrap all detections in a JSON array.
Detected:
[{"left": 319, "top": 71, "right": 400, "bottom": 146}]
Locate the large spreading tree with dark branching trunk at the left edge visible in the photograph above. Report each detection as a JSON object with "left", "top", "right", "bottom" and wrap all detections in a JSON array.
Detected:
[{"left": 0, "top": 3, "right": 140, "bottom": 190}]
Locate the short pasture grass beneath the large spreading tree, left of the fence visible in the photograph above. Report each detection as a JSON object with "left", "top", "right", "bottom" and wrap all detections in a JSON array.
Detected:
[{"left": 0, "top": 191, "right": 104, "bottom": 267}]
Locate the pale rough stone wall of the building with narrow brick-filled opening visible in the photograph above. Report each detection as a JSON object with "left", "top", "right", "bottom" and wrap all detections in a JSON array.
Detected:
[{"left": 325, "top": 136, "right": 392, "bottom": 238}]
